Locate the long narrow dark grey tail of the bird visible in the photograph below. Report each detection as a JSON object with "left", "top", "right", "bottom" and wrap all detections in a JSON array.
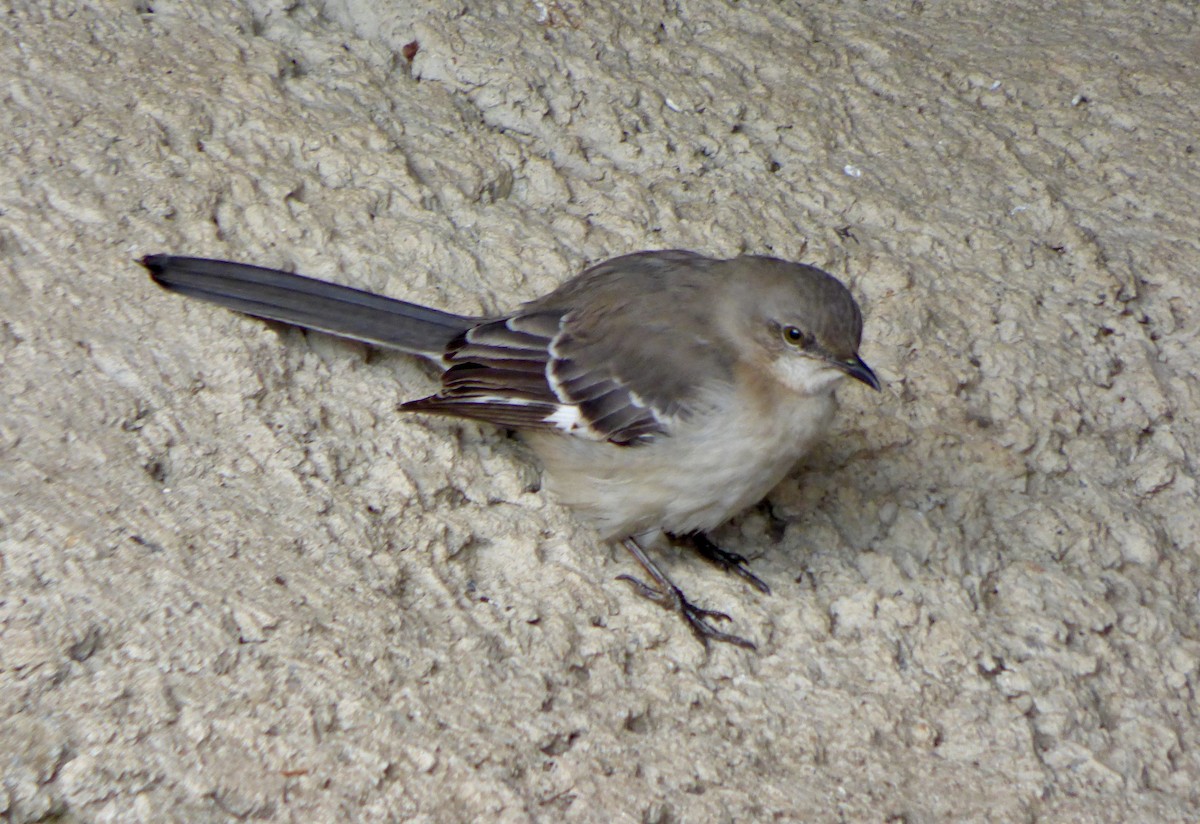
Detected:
[{"left": 142, "top": 254, "right": 479, "bottom": 360}]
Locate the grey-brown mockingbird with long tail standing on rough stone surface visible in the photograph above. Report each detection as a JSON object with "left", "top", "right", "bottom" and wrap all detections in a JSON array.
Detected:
[{"left": 143, "top": 251, "right": 880, "bottom": 649}]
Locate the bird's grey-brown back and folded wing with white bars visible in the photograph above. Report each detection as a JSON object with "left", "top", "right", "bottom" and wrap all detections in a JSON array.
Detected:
[{"left": 403, "top": 252, "right": 733, "bottom": 445}]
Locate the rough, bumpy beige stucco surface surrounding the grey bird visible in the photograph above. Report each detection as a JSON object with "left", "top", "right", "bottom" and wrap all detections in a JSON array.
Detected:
[{"left": 0, "top": 0, "right": 1200, "bottom": 822}]
